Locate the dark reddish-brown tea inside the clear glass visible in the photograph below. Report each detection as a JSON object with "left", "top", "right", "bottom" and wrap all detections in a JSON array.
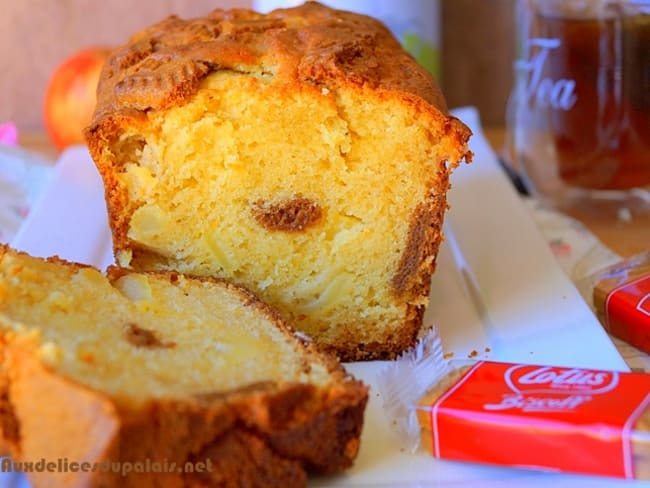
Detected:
[{"left": 540, "top": 15, "right": 650, "bottom": 190}]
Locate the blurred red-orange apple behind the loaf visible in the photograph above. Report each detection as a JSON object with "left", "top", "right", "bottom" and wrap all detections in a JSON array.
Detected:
[{"left": 43, "top": 46, "right": 111, "bottom": 150}]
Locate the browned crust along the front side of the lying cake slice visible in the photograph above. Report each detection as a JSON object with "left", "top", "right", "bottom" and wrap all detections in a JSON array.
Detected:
[{"left": 0, "top": 337, "right": 367, "bottom": 488}]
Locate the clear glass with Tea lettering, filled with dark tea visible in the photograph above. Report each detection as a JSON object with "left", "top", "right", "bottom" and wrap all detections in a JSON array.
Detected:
[{"left": 508, "top": 0, "right": 650, "bottom": 212}]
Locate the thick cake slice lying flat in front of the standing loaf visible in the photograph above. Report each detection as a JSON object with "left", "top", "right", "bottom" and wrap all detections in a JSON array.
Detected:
[{"left": 0, "top": 246, "right": 367, "bottom": 488}]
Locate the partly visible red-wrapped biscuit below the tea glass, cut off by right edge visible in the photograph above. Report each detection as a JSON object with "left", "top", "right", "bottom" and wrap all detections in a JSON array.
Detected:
[{"left": 593, "top": 252, "right": 650, "bottom": 353}]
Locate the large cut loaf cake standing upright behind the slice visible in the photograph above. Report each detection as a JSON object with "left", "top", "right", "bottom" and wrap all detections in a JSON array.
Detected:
[{"left": 85, "top": 2, "right": 471, "bottom": 360}]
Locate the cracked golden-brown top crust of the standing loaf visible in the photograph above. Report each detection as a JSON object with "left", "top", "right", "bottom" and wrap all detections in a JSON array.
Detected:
[{"left": 86, "top": 2, "right": 446, "bottom": 135}]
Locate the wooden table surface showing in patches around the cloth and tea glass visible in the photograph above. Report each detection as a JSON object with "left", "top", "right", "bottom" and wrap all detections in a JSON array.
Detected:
[{"left": 20, "top": 127, "right": 650, "bottom": 257}]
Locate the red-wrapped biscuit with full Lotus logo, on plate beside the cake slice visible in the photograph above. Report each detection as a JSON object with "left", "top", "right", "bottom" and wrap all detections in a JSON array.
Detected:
[{"left": 378, "top": 331, "right": 650, "bottom": 480}]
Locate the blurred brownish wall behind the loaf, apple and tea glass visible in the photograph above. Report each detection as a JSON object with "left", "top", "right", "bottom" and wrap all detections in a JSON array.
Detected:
[{"left": 0, "top": 0, "right": 514, "bottom": 131}]
